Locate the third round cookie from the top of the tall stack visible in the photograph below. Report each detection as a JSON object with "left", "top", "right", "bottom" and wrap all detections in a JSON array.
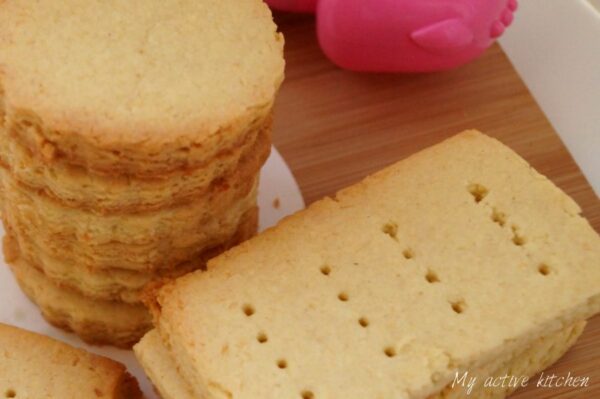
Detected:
[{"left": 2, "top": 178, "right": 258, "bottom": 272}]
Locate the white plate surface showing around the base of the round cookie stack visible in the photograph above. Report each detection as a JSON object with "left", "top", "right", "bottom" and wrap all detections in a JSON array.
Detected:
[{"left": 0, "top": 148, "right": 304, "bottom": 399}]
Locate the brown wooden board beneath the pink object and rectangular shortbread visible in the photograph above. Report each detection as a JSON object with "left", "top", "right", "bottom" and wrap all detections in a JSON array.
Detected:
[{"left": 274, "top": 14, "right": 600, "bottom": 399}]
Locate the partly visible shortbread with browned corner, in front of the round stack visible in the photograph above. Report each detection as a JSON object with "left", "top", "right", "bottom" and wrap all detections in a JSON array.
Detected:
[{"left": 0, "top": 323, "right": 143, "bottom": 399}]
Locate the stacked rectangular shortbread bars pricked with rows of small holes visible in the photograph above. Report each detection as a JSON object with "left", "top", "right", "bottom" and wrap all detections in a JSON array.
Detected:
[{"left": 135, "top": 131, "right": 600, "bottom": 399}]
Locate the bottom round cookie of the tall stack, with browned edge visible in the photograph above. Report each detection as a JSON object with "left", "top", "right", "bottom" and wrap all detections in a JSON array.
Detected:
[{"left": 3, "top": 235, "right": 152, "bottom": 348}]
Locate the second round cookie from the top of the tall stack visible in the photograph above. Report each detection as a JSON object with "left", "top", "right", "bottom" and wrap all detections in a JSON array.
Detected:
[{"left": 0, "top": 118, "right": 271, "bottom": 213}]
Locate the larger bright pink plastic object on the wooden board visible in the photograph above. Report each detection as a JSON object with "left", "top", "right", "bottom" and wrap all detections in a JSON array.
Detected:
[{"left": 317, "top": 0, "right": 517, "bottom": 72}]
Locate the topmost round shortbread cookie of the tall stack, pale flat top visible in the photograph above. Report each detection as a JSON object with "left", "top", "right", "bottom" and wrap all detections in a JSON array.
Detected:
[{"left": 0, "top": 0, "right": 284, "bottom": 177}]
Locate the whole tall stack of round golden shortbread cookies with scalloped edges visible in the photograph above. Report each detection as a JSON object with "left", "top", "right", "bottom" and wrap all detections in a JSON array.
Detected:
[{"left": 0, "top": 0, "right": 284, "bottom": 346}]
